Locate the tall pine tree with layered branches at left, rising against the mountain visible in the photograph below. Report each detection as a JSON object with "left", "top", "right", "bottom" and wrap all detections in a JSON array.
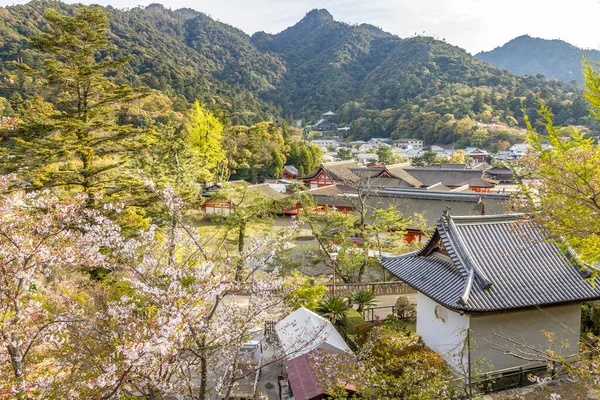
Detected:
[{"left": 11, "top": 7, "right": 143, "bottom": 206}]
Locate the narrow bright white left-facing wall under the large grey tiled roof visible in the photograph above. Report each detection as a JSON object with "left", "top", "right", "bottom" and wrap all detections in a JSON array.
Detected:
[{"left": 417, "top": 293, "right": 469, "bottom": 372}]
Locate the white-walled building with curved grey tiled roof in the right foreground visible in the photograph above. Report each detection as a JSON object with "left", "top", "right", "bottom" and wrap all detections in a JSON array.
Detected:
[{"left": 381, "top": 214, "right": 600, "bottom": 374}]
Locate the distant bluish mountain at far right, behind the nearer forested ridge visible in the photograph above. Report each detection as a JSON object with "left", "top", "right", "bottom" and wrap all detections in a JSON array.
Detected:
[{"left": 475, "top": 35, "right": 600, "bottom": 86}]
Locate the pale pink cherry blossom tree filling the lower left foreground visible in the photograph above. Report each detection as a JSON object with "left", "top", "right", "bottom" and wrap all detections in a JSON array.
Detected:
[{"left": 0, "top": 177, "right": 304, "bottom": 399}]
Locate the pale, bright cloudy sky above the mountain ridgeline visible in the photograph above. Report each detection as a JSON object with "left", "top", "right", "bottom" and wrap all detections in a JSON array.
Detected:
[{"left": 0, "top": 0, "right": 600, "bottom": 54}]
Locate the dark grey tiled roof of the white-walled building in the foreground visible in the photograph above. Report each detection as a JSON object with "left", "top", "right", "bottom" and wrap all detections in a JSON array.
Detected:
[{"left": 382, "top": 215, "right": 600, "bottom": 313}]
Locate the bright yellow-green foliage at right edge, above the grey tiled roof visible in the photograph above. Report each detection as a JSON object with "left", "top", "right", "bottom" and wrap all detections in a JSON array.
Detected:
[{"left": 516, "top": 98, "right": 600, "bottom": 265}]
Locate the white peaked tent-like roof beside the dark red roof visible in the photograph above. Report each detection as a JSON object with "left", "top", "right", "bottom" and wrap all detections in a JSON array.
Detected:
[{"left": 275, "top": 307, "right": 352, "bottom": 360}]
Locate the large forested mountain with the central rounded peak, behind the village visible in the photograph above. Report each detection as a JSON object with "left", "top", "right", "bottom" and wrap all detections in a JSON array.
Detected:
[{"left": 0, "top": 1, "right": 593, "bottom": 147}]
